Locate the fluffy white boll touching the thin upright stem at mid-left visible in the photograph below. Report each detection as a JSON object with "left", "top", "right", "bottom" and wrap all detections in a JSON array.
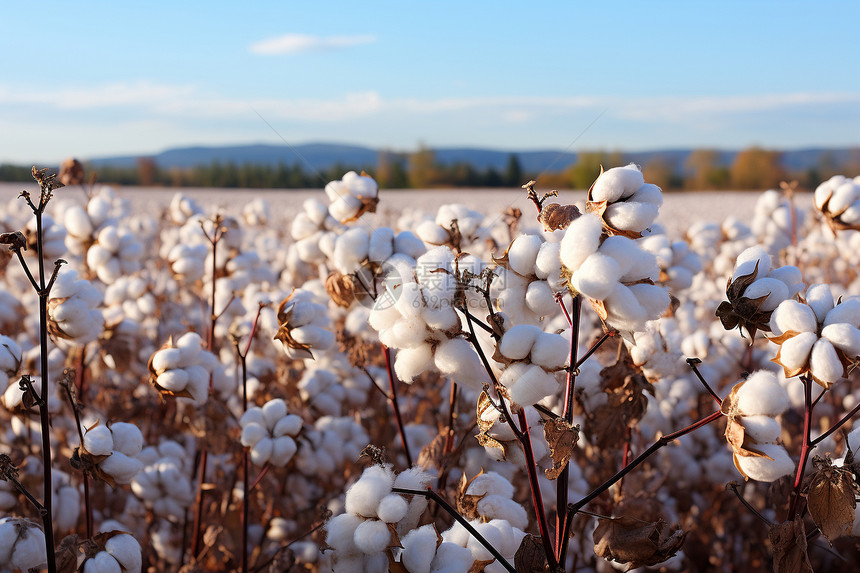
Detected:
[{"left": 148, "top": 332, "right": 218, "bottom": 406}]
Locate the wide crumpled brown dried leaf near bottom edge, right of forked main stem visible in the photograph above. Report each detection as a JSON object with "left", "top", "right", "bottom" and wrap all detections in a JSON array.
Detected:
[{"left": 593, "top": 516, "right": 686, "bottom": 569}]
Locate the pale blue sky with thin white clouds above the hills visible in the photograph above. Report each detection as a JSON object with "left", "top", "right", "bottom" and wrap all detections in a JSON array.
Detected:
[{"left": 0, "top": 0, "right": 860, "bottom": 164}]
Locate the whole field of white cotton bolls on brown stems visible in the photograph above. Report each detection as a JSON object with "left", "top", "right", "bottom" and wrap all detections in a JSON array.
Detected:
[{"left": 0, "top": 164, "right": 860, "bottom": 573}]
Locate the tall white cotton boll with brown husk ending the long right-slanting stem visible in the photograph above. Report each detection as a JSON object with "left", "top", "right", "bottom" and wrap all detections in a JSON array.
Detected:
[{"left": 722, "top": 370, "right": 794, "bottom": 482}]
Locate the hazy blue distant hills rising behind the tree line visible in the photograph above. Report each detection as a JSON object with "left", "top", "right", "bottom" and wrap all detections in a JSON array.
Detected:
[{"left": 88, "top": 143, "right": 860, "bottom": 173}]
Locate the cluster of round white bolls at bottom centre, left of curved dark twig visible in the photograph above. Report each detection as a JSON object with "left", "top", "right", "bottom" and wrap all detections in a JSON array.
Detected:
[{"left": 326, "top": 465, "right": 432, "bottom": 572}]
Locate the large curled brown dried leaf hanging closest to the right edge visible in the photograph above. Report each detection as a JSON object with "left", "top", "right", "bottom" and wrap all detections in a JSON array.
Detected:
[{"left": 806, "top": 456, "right": 858, "bottom": 545}]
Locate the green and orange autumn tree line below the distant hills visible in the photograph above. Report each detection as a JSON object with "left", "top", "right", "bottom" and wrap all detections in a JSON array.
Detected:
[{"left": 0, "top": 147, "right": 860, "bottom": 191}]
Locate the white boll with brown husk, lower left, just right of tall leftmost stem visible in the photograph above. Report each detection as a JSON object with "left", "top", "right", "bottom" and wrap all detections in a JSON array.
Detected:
[{"left": 77, "top": 422, "right": 143, "bottom": 485}]
